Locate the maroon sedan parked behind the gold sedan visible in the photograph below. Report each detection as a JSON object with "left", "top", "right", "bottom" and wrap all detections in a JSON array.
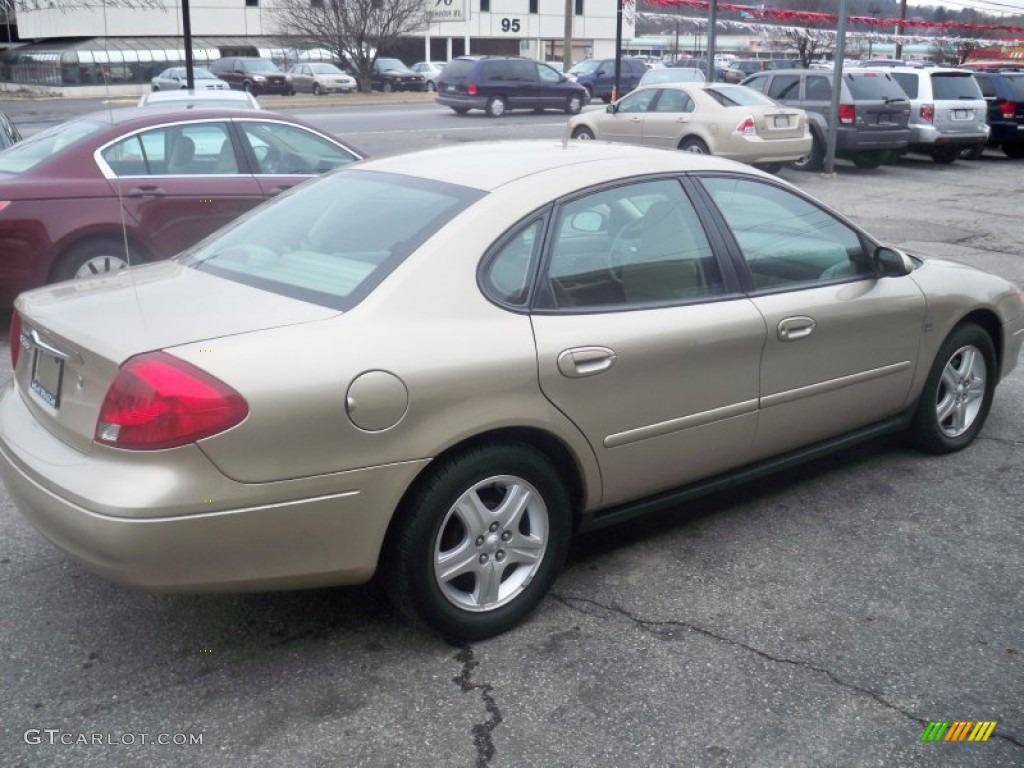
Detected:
[{"left": 0, "top": 108, "right": 361, "bottom": 306}]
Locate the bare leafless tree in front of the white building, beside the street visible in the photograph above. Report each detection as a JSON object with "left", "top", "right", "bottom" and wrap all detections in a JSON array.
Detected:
[{"left": 276, "top": 0, "right": 426, "bottom": 91}]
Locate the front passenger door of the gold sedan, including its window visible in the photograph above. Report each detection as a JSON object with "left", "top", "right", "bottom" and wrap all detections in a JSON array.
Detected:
[{"left": 702, "top": 176, "right": 926, "bottom": 458}]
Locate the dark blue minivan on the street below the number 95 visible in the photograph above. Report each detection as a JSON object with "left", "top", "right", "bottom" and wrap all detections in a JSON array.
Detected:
[{"left": 437, "top": 56, "right": 588, "bottom": 118}]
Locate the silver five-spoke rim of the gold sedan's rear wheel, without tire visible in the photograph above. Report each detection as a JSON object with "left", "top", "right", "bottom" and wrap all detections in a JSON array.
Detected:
[{"left": 434, "top": 475, "right": 549, "bottom": 611}]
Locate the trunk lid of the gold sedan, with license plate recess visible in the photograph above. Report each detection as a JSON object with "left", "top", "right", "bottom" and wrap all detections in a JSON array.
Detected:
[{"left": 12, "top": 262, "right": 338, "bottom": 452}]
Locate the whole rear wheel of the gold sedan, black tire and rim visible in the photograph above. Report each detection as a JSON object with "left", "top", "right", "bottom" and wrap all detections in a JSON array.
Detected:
[{"left": 378, "top": 442, "right": 571, "bottom": 642}]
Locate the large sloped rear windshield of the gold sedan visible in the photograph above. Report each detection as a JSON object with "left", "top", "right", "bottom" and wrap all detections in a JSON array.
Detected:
[{"left": 179, "top": 171, "right": 484, "bottom": 309}]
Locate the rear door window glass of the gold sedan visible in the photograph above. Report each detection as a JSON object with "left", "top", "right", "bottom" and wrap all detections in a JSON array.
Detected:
[{"left": 543, "top": 179, "right": 725, "bottom": 311}]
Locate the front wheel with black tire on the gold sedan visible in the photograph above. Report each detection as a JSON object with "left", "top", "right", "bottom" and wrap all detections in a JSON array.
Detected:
[{"left": 909, "top": 323, "right": 997, "bottom": 454}]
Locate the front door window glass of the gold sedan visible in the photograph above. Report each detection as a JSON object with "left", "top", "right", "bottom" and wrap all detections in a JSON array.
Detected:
[{"left": 702, "top": 176, "right": 873, "bottom": 291}]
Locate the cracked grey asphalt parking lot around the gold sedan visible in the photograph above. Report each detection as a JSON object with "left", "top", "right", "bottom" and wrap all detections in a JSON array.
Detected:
[{"left": 0, "top": 123, "right": 1024, "bottom": 768}]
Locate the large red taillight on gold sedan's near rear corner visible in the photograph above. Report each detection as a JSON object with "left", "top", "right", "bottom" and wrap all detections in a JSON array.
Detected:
[{"left": 95, "top": 352, "right": 249, "bottom": 451}]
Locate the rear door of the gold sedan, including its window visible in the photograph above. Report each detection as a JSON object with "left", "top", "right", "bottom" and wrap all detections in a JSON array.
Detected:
[{"left": 532, "top": 179, "right": 765, "bottom": 505}]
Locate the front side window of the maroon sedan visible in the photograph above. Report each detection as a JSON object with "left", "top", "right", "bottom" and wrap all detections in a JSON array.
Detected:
[{"left": 239, "top": 120, "right": 358, "bottom": 174}]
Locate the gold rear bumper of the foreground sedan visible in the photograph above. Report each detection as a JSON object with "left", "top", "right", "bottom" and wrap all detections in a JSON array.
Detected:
[{"left": 0, "top": 384, "right": 424, "bottom": 591}]
